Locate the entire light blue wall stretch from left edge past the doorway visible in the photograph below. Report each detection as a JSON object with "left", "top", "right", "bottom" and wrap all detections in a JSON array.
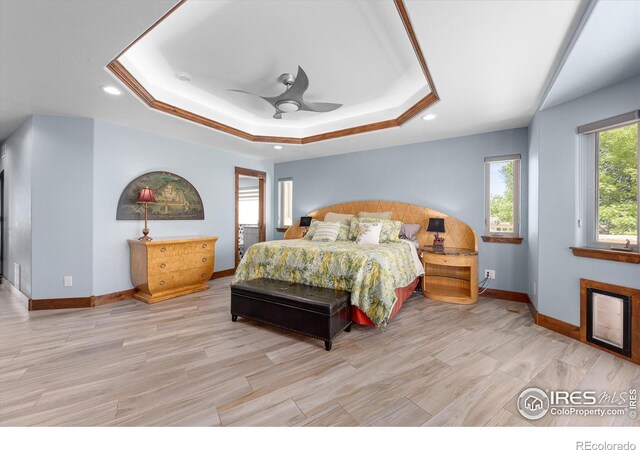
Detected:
[{"left": 0, "top": 115, "right": 273, "bottom": 299}]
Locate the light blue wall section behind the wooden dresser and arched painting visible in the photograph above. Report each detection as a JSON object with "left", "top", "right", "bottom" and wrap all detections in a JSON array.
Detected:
[{"left": 93, "top": 120, "right": 273, "bottom": 295}]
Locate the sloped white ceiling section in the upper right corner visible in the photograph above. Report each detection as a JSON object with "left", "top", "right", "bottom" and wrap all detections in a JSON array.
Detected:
[{"left": 543, "top": 0, "right": 640, "bottom": 109}]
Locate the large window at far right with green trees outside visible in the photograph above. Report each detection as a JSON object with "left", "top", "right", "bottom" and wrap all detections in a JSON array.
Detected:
[{"left": 578, "top": 111, "right": 640, "bottom": 251}]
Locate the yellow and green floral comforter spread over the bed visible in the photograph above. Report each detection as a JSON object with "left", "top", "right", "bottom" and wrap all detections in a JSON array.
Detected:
[{"left": 233, "top": 239, "right": 423, "bottom": 327}]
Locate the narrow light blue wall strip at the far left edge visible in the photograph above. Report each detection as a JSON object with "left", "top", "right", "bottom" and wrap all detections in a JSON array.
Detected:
[{"left": 0, "top": 117, "right": 33, "bottom": 297}]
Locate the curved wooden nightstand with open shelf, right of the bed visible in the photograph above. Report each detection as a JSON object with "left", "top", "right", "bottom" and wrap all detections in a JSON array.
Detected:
[{"left": 420, "top": 246, "right": 478, "bottom": 305}]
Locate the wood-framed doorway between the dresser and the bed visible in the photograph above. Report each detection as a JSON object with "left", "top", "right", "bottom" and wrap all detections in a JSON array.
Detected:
[{"left": 235, "top": 167, "right": 267, "bottom": 267}]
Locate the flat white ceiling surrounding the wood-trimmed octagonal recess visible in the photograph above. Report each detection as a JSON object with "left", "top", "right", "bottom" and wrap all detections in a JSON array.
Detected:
[{"left": 0, "top": 0, "right": 586, "bottom": 161}]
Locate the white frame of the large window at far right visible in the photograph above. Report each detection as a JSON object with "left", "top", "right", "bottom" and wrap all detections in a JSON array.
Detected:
[{"left": 577, "top": 111, "right": 640, "bottom": 252}]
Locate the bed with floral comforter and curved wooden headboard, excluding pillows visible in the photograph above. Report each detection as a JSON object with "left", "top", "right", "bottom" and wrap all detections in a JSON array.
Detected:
[{"left": 234, "top": 201, "right": 477, "bottom": 328}]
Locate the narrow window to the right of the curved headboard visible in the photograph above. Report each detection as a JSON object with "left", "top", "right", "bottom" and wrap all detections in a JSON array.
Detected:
[{"left": 484, "top": 155, "right": 520, "bottom": 237}]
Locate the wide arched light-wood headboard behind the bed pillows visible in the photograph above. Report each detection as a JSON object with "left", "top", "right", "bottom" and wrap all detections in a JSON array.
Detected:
[{"left": 284, "top": 200, "right": 478, "bottom": 251}]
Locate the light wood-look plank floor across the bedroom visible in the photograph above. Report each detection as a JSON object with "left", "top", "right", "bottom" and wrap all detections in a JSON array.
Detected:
[{"left": 0, "top": 278, "right": 640, "bottom": 426}]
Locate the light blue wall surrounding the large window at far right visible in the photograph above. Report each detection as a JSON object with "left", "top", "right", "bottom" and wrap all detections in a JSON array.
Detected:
[{"left": 536, "top": 78, "right": 640, "bottom": 325}]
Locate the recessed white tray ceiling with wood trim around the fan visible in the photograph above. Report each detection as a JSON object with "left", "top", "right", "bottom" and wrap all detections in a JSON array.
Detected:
[{"left": 108, "top": 0, "right": 438, "bottom": 144}]
